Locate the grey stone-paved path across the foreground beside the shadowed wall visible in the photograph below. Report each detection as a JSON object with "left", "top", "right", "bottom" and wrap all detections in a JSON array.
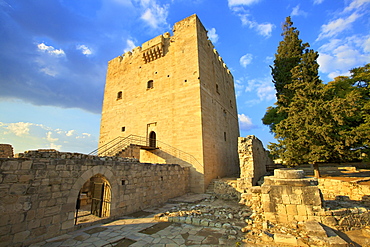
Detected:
[{"left": 31, "top": 195, "right": 241, "bottom": 247}]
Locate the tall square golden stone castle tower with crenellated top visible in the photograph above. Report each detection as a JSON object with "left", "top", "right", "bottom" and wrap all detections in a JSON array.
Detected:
[{"left": 99, "top": 15, "right": 239, "bottom": 192}]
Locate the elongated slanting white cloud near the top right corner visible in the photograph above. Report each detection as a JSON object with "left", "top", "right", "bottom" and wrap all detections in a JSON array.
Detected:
[{"left": 317, "top": 13, "right": 362, "bottom": 40}]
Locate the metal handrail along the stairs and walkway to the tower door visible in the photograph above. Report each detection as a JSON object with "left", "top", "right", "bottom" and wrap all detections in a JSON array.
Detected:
[{"left": 89, "top": 135, "right": 203, "bottom": 170}]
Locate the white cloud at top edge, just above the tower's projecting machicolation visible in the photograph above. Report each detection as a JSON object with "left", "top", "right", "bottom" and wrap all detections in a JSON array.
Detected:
[{"left": 140, "top": 0, "right": 169, "bottom": 29}]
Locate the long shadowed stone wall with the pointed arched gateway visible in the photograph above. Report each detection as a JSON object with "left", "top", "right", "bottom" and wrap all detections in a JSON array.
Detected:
[{"left": 0, "top": 152, "right": 189, "bottom": 246}]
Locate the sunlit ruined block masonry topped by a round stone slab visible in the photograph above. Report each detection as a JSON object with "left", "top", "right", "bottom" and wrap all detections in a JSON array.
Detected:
[{"left": 240, "top": 169, "right": 370, "bottom": 233}]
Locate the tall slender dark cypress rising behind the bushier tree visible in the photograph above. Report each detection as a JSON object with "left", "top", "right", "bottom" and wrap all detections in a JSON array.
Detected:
[{"left": 262, "top": 16, "right": 309, "bottom": 132}]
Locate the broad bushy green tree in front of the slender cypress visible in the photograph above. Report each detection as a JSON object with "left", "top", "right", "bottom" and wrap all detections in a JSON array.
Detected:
[{"left": 269, "top": 60, "right": 370, "bottom": 176}]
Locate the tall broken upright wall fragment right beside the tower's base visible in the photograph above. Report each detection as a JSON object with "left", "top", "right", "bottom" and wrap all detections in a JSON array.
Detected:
[{"left": 238, "top": 135, "right": 274, "bottom": 188}]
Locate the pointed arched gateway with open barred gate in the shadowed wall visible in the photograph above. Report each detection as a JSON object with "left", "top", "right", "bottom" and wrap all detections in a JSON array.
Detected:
[{"left": 75, "top": 174, "right": 112, "bottom": 224}]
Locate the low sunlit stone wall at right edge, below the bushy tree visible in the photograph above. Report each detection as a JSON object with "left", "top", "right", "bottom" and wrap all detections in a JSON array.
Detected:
[{"left": 318, "top": 178, "right": 370, "bottom": 206}]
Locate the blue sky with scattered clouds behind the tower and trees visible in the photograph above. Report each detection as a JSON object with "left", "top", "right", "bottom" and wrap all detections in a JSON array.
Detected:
[{"left": 0, "top": 0, "right": 370, "bottom": 153}]
